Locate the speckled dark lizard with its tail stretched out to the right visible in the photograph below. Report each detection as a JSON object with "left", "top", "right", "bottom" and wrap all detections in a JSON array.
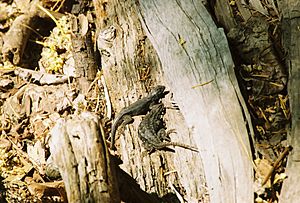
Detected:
[{"left": 138, "top": 103, "right": 198, "bottom": 152}]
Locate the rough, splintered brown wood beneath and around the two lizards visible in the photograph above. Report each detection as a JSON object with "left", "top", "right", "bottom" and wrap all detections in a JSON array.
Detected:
[{"left": 97, "top": 1, "right": 209, "bottom": 202}]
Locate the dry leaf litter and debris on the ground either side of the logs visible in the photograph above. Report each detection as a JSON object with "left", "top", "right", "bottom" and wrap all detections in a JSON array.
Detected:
[{"left": 0, "top": 1, "right": 290, "bottom": 202}]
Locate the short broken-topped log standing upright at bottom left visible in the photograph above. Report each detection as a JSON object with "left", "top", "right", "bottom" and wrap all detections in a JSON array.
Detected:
[{"left": 49, "top": 113, "right": 120, "bottom": 203}]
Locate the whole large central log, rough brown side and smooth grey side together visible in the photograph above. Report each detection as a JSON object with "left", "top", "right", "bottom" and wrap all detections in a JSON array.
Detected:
[{"left": 94, "top": 0, "right": 253, "bottom": 202}]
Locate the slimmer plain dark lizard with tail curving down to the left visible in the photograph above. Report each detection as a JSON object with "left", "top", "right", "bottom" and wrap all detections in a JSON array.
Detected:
[{"left": 111, "top": 85, "right": 169, "bottom": 148}]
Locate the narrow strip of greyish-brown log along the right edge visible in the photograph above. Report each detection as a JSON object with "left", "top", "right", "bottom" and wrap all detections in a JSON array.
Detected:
[{"left": 280, "top": 0, "right": 300, "bottom": 203}]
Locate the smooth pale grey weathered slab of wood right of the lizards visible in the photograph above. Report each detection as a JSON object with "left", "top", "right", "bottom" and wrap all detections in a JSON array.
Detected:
[{"left": 140, "top": 0, "right": 253, "bottom": 202}]
